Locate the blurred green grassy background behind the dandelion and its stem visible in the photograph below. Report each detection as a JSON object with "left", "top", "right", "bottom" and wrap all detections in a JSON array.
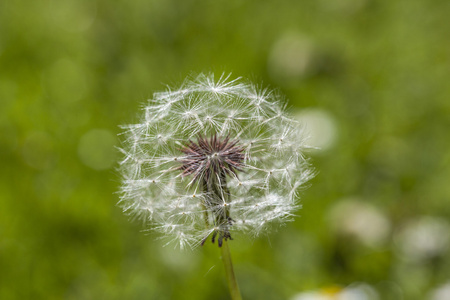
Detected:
[{"left": 0, "top": 0, "right": 450, "bottom": 300}]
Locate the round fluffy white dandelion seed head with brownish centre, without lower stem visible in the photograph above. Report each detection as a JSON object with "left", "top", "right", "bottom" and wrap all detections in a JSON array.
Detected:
[{"left": 119, "top": 74, "right": 312, "bottom": 248}]
